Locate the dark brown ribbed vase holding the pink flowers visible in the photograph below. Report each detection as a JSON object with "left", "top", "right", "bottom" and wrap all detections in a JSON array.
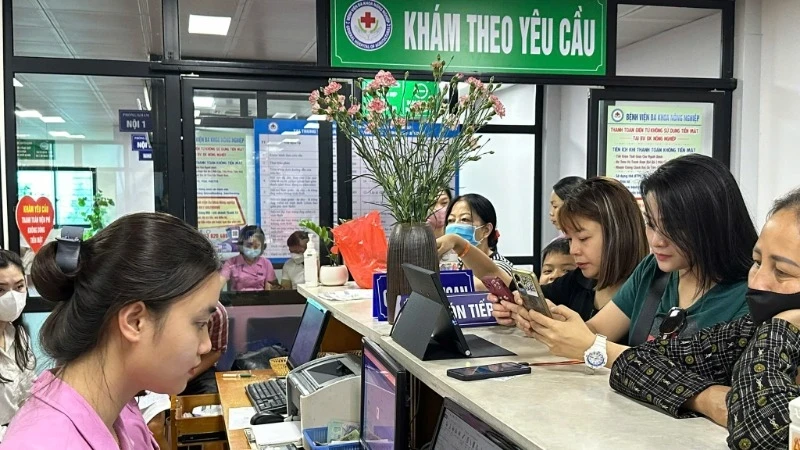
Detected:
[{"left": 386, "top": 223, "right": 439, "bottom": 324}]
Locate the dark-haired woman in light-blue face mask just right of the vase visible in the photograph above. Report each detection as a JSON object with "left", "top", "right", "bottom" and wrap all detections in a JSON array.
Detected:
[{"left": 436, "top": 194, "right": 514, "bottom": 290}]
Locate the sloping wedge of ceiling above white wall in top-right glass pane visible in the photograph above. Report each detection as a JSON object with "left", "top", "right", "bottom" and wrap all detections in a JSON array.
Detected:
[{"left": 617, "top": 5, "right": 720, "bottom": 48}]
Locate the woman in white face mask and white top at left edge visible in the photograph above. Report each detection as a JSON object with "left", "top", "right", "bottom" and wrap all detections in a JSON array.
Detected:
[{"left": 0, "top": 250, "right": 36, "bottom": 439}]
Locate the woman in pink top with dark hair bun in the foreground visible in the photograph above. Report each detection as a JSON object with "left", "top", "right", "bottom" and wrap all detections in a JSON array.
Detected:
[{"left": 0, "top": 213, "right": 221, "bottom": 450}]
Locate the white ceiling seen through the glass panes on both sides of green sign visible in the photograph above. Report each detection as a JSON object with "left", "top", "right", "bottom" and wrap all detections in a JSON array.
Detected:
[{"left": 7, "top": 0, "right": 718, "bottom": 141}]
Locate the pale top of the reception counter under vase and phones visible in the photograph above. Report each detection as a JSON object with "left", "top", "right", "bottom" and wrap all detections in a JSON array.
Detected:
[{"left": 298, "top": 287, "right": 727, "bottom": 450}]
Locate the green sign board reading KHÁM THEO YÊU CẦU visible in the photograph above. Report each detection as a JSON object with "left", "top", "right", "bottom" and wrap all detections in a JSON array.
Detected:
[{"left": 331, "top": 0, "right": 607, "bottom": 75}]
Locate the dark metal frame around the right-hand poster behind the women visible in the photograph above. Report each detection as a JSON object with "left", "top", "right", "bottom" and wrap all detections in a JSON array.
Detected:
[{"left": 586, "top": 89, "right": 733, "bottom": 177}]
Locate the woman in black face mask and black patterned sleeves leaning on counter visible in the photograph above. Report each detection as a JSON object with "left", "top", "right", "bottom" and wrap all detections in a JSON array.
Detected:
[{"left": 610, "top": 190, "right": 800, "bottom": 450}]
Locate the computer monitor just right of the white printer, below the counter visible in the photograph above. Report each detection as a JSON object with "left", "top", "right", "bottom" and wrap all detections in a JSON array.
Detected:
[{"left": 360, "top": 338, "right": 410, "bottom": 450}]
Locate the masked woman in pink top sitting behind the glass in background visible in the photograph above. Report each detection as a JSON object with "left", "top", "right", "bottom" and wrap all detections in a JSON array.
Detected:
[{"left": 219, "top": 225, "right": 278, "bottom": 291}]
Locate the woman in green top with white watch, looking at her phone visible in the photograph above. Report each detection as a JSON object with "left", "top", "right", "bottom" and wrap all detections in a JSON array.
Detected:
[{"left": 510, "top": 155, "right": 758, "bottom": 367}]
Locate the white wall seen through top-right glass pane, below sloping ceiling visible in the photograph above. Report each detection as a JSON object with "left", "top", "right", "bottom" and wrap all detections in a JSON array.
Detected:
[{"left": 617, "top": 13, "right": 722, "bottom": 78}]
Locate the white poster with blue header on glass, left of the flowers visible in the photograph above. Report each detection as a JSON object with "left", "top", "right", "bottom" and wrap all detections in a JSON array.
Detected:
[{"left": 254, "top": 119, "right": 319, "bottom": 262}]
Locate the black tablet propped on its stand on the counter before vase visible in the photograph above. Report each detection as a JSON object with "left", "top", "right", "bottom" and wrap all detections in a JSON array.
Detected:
[{"left": 392, "top": 295, "right": 516, "bottom": 361}]
